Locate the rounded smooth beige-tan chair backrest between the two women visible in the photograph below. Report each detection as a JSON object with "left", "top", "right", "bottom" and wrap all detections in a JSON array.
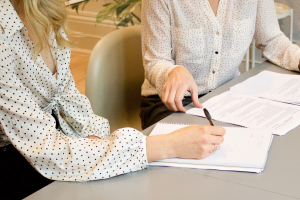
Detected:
[{"left": 85, "top": 26, "right": 144, "bottom": 131}]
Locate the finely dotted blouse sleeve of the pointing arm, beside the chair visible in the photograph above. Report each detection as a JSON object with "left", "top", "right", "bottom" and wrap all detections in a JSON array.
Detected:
[{"left": 142, "top": 0, "right": 178, "bottom": 97}]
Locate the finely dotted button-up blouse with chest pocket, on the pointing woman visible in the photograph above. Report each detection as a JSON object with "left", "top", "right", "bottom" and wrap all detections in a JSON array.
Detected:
[{"left": 142, "top": 0, "right": 300, "bottom": 96}]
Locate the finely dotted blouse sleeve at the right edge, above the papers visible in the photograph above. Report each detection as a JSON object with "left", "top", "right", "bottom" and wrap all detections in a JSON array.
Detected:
[{"left": 254, "top": 0, "right": 300, "bottom": 71}]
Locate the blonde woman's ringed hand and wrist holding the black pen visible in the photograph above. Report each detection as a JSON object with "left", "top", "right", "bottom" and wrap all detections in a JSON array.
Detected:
[{"left": 147, "top": 125, "right": 225, "bottom": 162}]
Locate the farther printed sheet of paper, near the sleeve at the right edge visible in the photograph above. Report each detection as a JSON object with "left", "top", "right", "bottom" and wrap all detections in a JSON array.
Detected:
[{"left": 230, "top": 71, "right": 300, "bottom": 105}]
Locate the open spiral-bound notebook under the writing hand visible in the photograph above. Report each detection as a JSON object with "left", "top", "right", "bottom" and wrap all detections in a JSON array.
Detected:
[{"left": 149, "top": 123, "right": 272, "bottom": 172}]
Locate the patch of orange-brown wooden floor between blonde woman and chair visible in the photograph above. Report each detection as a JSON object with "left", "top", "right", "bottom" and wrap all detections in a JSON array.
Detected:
[{"left": 70, "top": 52, "right": 90, "bottom": 94}]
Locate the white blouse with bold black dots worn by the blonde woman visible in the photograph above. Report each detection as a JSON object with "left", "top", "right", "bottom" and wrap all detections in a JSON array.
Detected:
[{"left": 0, "top": 0, "right": 148, "bottom": 181}]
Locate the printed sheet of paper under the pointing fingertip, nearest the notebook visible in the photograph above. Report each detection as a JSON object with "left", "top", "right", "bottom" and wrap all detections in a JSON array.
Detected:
[{"left": 187, "top": 91, "right": 300, "bottom": 135}]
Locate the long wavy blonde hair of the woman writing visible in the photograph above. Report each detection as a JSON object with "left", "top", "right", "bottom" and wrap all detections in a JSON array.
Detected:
[{"left": 23, "top": 0, "right": 71, "bottom": 58}]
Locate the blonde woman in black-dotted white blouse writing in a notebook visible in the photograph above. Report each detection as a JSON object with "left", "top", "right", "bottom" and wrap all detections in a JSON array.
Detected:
[{"left": 0, "top": 0, "right": 225, "bottom": 199}]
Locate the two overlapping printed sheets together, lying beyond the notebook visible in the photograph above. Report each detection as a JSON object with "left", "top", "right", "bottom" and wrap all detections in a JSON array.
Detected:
[{"left": 187, "top": 72, "right": 300, "bottom": 135}]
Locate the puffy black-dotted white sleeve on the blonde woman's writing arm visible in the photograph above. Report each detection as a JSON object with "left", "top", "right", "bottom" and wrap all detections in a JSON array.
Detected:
[{"left": 0, "top": 45, "right": 148, "bottom": 181}]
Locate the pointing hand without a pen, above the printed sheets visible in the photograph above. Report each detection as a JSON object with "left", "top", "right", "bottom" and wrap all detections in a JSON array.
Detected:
[{"left": 162, "top": 66, "right": 203, "bottom": 112}]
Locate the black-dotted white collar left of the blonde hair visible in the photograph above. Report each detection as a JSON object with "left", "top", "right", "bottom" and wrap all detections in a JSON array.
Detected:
[{"left": 0, "top": 0, "right": 24, "bottom": 37}]
